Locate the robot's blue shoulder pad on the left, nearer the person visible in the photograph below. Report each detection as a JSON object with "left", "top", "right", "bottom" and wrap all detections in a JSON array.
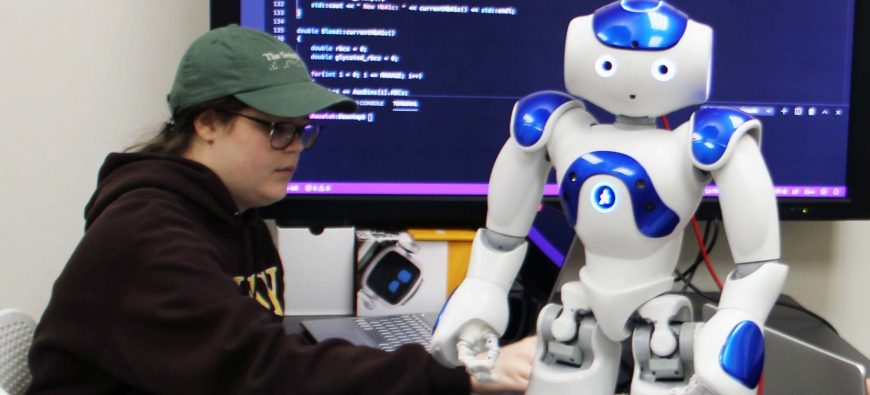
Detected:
[{"left": 511, "top": 91, "right": 579, "bottom": 148}]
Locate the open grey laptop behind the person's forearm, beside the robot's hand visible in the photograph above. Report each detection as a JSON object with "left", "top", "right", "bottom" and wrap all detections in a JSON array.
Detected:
[{"left": 300, "top": 313, "right": 438, "bottom": 351}]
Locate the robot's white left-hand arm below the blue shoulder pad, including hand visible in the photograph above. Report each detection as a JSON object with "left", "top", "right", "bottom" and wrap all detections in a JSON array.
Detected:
[{"left": 432, "top": 141, "right": 549, "bottom": 367}]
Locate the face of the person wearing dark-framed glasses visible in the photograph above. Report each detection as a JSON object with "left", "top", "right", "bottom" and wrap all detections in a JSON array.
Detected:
[{"left": 199, "top": 108, "right": 308, "bottom": 211}]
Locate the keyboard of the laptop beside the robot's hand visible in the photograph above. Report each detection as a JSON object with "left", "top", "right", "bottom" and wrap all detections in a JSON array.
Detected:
[{"left": 354, "top": 314, "right": 432, "bottom": 351}]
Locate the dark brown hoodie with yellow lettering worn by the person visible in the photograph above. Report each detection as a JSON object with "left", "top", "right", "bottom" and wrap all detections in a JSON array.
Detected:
[{"left": 29, "top": 154, "right": 470, "bottom": 395}]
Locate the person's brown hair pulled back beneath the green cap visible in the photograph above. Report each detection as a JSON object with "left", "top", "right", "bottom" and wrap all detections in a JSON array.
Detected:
[{"left": 124, "top": 96, "right": 247, "bottom": 156}]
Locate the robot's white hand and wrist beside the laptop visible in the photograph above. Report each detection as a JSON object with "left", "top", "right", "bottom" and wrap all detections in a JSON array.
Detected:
[{"left": 432, "top": 278, "right": 508, "bottom": 382}]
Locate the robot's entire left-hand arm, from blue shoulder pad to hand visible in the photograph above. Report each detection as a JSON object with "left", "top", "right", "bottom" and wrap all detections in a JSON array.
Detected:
[{"left": 432, "top": 92, "right": 582, "bottom": 373}]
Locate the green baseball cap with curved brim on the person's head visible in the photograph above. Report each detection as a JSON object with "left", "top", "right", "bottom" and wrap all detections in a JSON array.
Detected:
[{"left": 167, "top": 25, "right": 356, "bottom": 118}]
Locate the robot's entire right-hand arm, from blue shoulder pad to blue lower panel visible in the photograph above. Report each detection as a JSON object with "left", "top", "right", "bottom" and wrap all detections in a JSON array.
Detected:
[{"left": 692, "top": 109, "right": 788, "bottom": 394}]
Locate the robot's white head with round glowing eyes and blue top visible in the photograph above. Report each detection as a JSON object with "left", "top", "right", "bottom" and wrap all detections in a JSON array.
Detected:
[{"left": 565, "top": 0, "right": 713, "bottom": 117}]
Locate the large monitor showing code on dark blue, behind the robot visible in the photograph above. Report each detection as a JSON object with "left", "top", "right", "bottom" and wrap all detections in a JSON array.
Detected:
[{"left": 212, "top": 0, "right": 870, "bottom": 227}]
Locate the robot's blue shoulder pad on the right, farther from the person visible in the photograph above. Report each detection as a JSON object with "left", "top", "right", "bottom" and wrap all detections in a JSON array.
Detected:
[{"left": 692, "top": 107, "right": 761, "bottom": 170}]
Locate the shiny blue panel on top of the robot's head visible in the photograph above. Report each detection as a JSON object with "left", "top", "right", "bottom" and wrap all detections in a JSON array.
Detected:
[{"left": 592, "top": 0, "right": 689, "bottom": 50}]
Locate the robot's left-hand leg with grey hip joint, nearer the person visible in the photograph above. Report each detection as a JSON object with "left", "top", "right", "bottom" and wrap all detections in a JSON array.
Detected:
[{"left": 526, "top": 282, "right": 622, "bottom": 395}]
